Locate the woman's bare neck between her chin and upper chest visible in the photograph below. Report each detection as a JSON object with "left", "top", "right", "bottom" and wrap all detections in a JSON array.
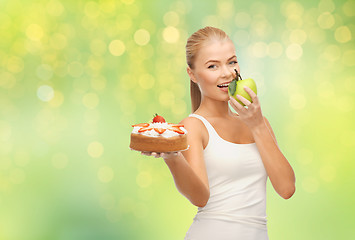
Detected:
[{"left": 196, "top": 97, "right": 233, "bottom": 117}]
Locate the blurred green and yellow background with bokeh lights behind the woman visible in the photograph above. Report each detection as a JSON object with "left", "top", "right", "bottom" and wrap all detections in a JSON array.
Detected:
[{"left": 0, "top": 0, "right": 355, "bottom": 240}]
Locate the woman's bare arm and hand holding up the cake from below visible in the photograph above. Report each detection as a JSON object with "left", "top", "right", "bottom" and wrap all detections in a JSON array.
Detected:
[{"left": 142, "top": 118, "right": 210, "bottom": 207}]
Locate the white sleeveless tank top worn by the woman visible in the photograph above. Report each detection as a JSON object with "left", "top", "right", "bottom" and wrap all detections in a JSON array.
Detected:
[{"left": 190, "top": 114, "right": 267, "bottom": 231}]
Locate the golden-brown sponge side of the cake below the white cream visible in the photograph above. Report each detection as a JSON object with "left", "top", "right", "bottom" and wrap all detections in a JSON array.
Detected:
[{"left": 129, "top": 133, "right": 188, "bottom": 152}]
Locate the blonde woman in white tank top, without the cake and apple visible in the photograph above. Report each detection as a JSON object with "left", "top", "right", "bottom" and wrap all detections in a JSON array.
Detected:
[{"left": 143, "top": 27, "right": 295, "bottom": 240}]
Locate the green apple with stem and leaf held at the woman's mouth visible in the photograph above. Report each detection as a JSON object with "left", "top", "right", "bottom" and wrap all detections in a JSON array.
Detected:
[{"left": 228, "top": 69, "right": 257, "bottom": 106}]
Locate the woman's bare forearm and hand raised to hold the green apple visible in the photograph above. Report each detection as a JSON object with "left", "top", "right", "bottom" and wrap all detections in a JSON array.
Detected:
[{"left": 230, "top": 87, "right": 295, "bottom": 199}]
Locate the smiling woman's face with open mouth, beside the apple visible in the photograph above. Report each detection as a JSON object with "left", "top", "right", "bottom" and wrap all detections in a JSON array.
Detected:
[{"left": 188, "top": 40, "right": 240, "bottom": 101}]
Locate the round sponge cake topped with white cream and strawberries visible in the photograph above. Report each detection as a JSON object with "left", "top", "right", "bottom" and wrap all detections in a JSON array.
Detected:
[{"left": 129, "top": 114, "right": 188, "bottom": 153}]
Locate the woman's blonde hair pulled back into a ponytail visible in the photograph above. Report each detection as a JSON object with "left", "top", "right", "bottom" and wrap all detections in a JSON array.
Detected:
[{"left": 185, "top": 27, "right": 230, "bottom": 112}]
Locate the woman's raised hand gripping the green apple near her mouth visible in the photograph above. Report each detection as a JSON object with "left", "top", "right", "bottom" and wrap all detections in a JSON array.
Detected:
[{"left": 229, "top": 86, "right": 264, "bottom": 129}]
